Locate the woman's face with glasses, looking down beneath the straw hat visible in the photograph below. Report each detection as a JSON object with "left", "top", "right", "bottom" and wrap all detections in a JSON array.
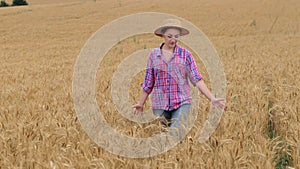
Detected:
[{"left": 163, "top": 28, "right": 180, "bottom": 49}]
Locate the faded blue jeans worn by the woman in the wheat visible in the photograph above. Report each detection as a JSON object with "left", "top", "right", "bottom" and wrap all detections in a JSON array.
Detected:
[{"left": 152, "top": 104, "right": 191, "bottom": 140}]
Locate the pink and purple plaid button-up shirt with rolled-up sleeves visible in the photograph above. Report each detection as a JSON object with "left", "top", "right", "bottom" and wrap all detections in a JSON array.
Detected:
[{"left": 142, "top": 44, "right": 202, "bottom": 111}]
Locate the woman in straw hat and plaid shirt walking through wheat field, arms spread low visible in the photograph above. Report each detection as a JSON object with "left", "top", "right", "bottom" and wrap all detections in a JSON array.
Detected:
[{"left": 132, "top": 19, "right": 225, "bottom": 139}]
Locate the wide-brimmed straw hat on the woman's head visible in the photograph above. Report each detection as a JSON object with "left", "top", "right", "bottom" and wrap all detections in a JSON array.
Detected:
[{"left": 154, "top": 19, "right": 190, "bottom": 37}]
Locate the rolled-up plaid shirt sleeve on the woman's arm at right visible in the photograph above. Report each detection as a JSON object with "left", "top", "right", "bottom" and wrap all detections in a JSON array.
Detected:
[{"left": 187, "top": 52, "right": 202, "bottom": 86}]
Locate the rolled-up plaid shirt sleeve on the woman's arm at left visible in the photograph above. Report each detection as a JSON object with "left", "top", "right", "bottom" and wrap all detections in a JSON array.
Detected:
[{"left": 141, "top": 52, "right": 154, "bottom": 94}]
